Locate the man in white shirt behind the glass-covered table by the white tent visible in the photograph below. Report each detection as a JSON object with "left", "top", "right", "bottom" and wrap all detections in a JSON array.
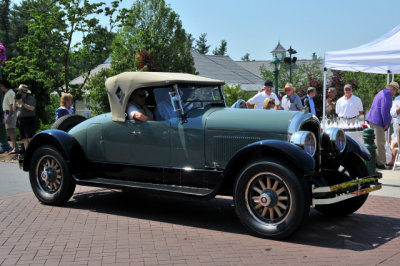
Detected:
[{"left": 336, "top": 84, "right": 363, "bottom": 124}]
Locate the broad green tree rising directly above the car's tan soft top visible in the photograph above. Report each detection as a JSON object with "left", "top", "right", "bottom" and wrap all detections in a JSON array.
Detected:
[{"left": 111, "top": 0, "right": 195, "bottom": 73}]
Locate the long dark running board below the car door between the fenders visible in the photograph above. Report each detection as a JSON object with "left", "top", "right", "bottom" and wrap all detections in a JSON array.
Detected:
[{"left": 75, "top": 178, "right": 213, "bottom": 197}]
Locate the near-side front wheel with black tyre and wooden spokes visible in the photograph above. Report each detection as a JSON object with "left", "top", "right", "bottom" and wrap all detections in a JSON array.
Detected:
[{"left": 234, "top": 159, "right": 310, "bottom": 239}]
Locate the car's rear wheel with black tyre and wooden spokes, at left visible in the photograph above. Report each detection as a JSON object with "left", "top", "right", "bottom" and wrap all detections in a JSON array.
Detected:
[{"left": 29, "top": 146, "right": 76, "bottom": 205}]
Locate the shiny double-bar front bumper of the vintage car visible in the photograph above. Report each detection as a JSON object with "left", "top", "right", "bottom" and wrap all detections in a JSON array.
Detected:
[{"left": 312, "top": 173, "right": 382, "bottom": 206}]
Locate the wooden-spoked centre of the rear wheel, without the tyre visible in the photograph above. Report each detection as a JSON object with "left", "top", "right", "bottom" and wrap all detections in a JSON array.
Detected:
[{"left": 36, "top": 156, "right": 62, "bottom": 193}]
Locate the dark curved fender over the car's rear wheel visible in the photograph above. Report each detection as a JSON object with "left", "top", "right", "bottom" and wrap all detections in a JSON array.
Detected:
[{"left": 20, "top": 129, "right": 85, "bottom": 171}]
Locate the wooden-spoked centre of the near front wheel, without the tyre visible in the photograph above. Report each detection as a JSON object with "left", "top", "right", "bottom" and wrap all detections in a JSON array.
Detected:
[{"left": 246, "top": 173, "right": 291, "bottom": 224}]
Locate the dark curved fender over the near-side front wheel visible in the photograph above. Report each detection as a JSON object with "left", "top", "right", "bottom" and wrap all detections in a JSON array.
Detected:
[{"left": 225, "top": 140, "right": 315, "bottom": 175}]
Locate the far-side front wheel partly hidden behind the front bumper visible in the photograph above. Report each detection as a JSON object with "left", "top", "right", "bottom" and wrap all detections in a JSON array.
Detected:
[{"left": 315, "top": 156, "right": 369, "bottom": 216}]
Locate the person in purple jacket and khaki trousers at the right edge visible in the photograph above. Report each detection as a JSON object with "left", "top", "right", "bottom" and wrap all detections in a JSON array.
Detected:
[{"left": 365, "top": 81, "right": 399, "bottom": 169}]
